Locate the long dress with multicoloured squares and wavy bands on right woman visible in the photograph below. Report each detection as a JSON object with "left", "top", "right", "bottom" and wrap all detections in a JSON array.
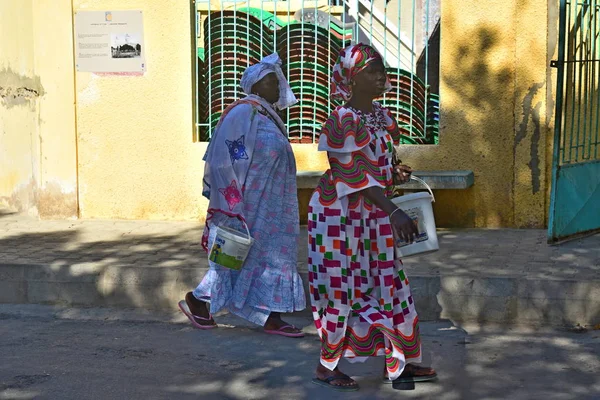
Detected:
[{"left": 308, "top": 103, "right": 421, "bottom": 379}]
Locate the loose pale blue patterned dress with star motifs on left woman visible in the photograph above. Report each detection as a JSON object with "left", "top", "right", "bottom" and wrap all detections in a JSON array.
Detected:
[{"left": 193, "top": 96, "right": 306, "bottom": 326}]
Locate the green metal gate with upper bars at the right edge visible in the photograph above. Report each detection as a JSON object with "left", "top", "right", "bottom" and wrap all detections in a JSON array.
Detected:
[{"left": 548, "top": 0, "right": 600, "bottom": 242}]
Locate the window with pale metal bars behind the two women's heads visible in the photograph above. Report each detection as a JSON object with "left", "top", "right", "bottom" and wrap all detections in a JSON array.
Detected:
[{"left": 194, "top": 0, "right": 440, "bottom": 144}]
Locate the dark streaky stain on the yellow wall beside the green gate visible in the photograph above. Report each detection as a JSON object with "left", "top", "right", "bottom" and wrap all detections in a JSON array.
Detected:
[{"left": 513, "top": 82, "right": 545, "bottom": 194}]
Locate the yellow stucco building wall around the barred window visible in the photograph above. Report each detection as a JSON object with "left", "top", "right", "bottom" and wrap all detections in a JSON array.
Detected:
[{"left": 0, "top": 0, "right": 556, "bottom": 227}]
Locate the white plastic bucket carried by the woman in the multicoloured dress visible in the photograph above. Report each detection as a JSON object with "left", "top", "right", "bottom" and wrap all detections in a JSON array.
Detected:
[{"left": 392, "top": 176, "right": 440, "bottom": 257}]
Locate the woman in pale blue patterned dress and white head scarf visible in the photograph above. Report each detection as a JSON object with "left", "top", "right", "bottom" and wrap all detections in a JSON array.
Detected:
[{"left": 179, "top": 54, "right": 306, "bottom": 337}]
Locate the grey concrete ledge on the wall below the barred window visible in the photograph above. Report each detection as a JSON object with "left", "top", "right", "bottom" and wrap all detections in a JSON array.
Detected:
[{"left": 296, "top": 170, "right": 475, "bottom": 190}]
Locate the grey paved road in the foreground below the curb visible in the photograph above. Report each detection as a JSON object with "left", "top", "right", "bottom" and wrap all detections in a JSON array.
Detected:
[{"left": 0, "top": 305, "right": 600, "bottom": 400}]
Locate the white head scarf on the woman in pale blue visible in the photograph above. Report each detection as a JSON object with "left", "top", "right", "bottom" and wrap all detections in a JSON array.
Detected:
[{"left": 240, "top": 53, "right": 298, "bottom": 110}]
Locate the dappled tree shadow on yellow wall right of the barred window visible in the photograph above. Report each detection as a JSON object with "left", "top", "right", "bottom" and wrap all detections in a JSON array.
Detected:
[{"left": 434, "top": 28, "right": 512, "bottom": 227}]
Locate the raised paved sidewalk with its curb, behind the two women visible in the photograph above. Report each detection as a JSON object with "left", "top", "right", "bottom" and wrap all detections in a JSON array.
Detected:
[{"left": 0, "top": 212, "right": 600, "bottom": 325}]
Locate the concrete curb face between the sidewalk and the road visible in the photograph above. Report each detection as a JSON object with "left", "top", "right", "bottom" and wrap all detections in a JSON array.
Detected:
[{"left": 0, "top": 263, "right": 600, "bottom": 325}]
